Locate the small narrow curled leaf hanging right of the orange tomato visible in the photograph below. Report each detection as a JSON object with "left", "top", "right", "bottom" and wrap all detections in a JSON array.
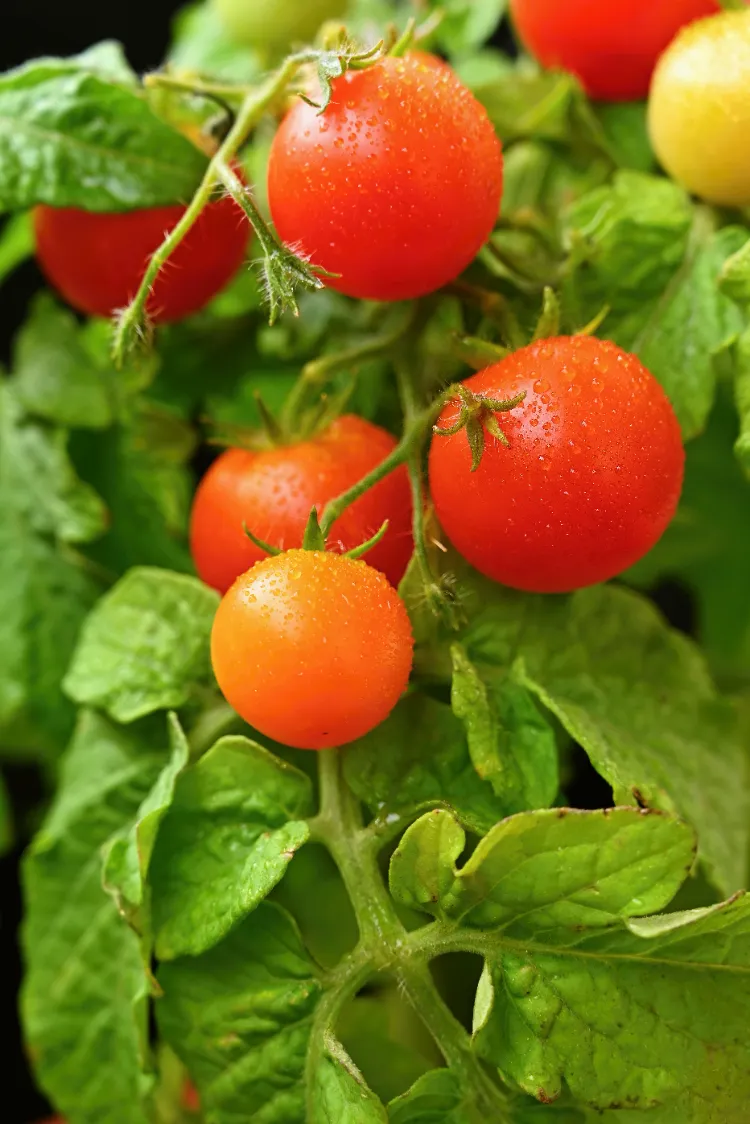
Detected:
[{"left": 451, "top": 644, "right": 558, "bottom": 812}]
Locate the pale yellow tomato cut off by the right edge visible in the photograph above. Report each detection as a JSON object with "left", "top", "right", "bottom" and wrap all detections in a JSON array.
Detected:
[{"left": 649, "top": 10, "right": 750, "bottom": 207}]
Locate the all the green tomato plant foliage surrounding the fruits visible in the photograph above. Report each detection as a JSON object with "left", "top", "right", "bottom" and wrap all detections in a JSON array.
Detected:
[{"left": 0, "top": 0, "right": 750, "bottom": 1124}]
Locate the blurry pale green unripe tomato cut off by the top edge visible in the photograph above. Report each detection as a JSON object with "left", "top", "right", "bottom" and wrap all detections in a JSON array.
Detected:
[{"left": 214, "top": 0, "right": 346, "bottom": 52}]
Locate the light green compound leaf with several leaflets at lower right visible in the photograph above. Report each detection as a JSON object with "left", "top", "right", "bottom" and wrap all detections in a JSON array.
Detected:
[{"left": 391, "top": 808, "right": 750, "bottom": 1124}]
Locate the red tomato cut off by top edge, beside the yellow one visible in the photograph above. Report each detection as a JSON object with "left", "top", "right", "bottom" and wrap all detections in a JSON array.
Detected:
[{"left": 510, "top": 0, "right": 720, "bottom": 101}]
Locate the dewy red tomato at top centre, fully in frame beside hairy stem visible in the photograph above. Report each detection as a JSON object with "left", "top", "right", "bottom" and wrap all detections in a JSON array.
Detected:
[{"left": 268, "top": 53, "right": 503, "bottom": 300}]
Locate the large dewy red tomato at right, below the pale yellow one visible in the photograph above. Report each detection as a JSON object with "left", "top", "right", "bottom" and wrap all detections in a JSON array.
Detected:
[{"left": 430, "top": 336, "right": 685, "bottom": 593}]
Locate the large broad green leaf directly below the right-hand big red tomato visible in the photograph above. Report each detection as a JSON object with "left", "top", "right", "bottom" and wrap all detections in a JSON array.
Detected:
[{"left": 415, "top": 556, "right": 750, "bottom": 892}]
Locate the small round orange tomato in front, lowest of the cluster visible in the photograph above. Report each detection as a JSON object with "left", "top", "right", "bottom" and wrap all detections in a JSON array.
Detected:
[{"left": 211, "top": 550, "right": 413, "bottom": 750}]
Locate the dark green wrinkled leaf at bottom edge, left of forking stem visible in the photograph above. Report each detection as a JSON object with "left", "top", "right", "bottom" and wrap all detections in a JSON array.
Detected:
[{"left": 156, "top": 901, "right": 322, "bottom": 1124}]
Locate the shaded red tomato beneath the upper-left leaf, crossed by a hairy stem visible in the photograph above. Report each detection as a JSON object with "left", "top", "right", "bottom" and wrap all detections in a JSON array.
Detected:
[{"left": 34, "top": 197, "right": 250, "bottom": 324}]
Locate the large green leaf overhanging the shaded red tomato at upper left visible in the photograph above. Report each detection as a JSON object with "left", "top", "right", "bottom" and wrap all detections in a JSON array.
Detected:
[{"left": 0, "top": 48, "right": 207, "bottom": 211}]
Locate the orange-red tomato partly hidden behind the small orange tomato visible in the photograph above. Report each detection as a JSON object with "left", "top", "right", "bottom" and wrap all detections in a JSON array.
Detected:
[{"left": 190, "top": 415, "right": 413, "bottom": 593}]
